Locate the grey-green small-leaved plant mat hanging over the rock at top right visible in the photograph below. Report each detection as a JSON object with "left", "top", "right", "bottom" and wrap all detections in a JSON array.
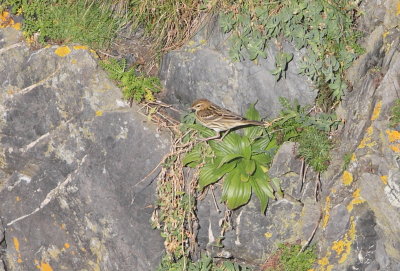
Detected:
[{"left": 220, "top": 0, "right": 363, "bottom": 100}]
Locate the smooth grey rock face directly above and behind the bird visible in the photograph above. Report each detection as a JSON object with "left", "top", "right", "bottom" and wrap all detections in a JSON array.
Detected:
[{"left": 160, "top": 17, "right": 316, "bottom": 117}]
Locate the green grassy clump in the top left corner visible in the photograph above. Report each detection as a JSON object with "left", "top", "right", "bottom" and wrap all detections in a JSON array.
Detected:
[{"left": 0, "top": 0, "right": 128, "bottom": 48}]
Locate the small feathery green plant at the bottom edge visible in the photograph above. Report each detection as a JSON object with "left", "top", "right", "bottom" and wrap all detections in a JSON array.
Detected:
[{"left": 264, "top": 244, "right": 317, "bottom": 271}]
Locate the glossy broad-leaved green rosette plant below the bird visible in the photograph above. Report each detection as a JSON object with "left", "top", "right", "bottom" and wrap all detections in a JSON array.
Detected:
[{"left": 183, "top": 105, "right": 280, "bottom": 213}]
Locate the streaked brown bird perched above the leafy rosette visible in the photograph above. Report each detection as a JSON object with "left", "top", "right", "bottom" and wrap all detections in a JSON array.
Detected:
[{"left": 191, "top": 99, "right": 268, "bottom": 140}]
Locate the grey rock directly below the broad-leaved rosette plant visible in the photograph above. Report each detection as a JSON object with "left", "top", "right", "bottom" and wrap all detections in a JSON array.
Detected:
[{"left": 223, "top": 199, "right": 308, "bottom": 264}]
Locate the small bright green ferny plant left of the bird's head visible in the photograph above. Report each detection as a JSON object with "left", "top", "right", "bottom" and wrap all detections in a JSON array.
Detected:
[{"left": 100, "top": 59, "right": 161, "bottom": 102}]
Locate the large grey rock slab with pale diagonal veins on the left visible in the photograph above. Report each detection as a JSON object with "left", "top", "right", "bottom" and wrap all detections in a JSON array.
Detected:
[{"left": 0, "top": 28, "right": 169, "bottom": 271}]
